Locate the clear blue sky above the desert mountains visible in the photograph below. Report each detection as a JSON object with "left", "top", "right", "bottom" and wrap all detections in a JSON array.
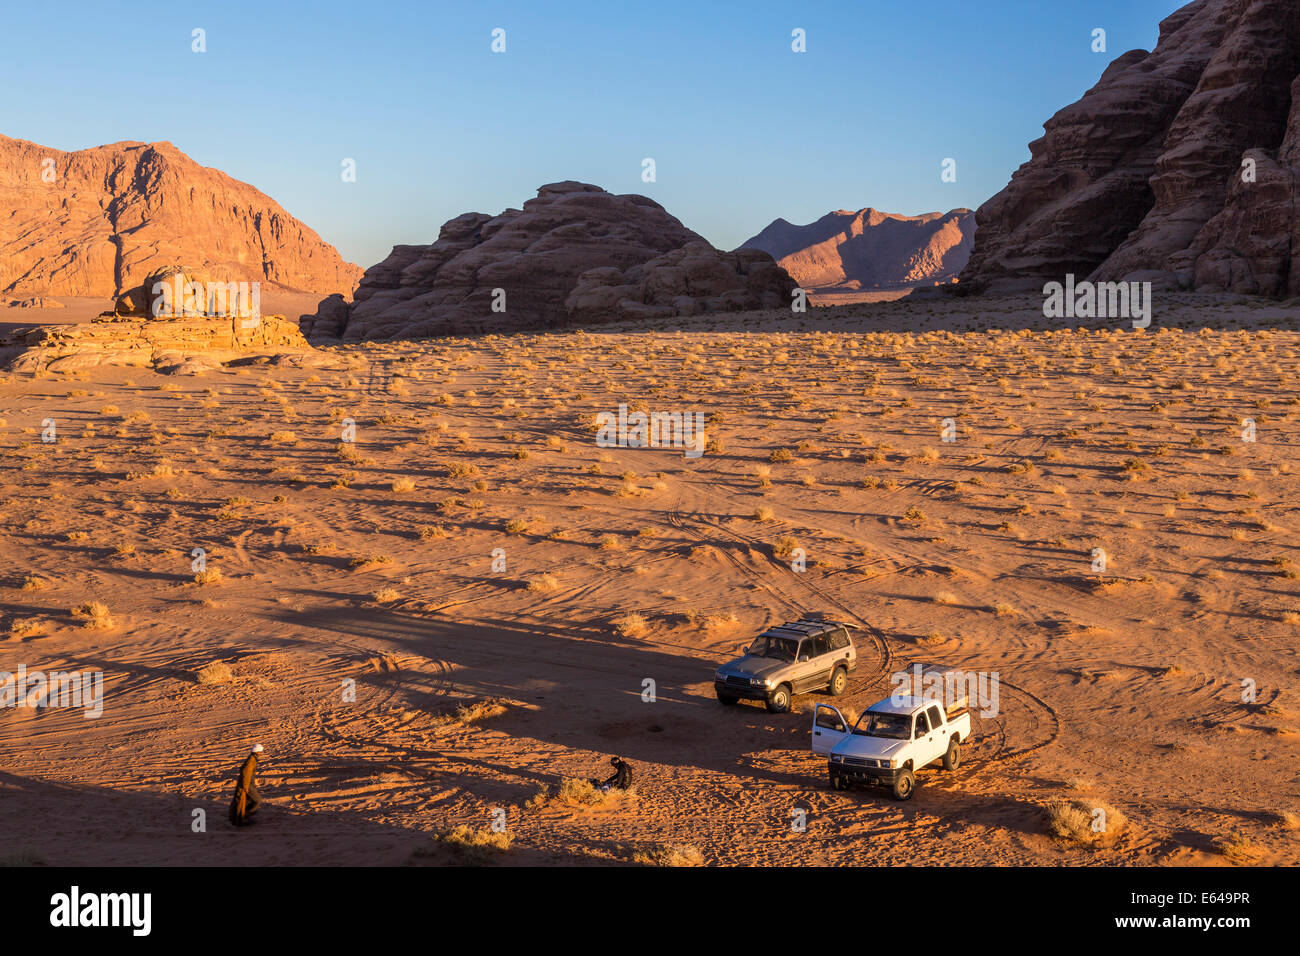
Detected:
[{"left": 0, "top": 0, "right": 1182, "bottom": 265}]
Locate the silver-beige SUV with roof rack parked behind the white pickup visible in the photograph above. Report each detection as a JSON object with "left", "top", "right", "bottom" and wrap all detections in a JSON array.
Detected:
[{"left": 714, "top": 619, "right": 858, "bottom": 714}]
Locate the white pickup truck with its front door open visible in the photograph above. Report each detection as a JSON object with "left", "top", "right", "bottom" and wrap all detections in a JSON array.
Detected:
[{"left": 813, "top": 696, "right": 971, "bottom": 800}]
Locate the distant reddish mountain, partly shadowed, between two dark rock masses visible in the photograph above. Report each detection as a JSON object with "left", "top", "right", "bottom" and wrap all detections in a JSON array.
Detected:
[{"left": 741, "top": 208, "right": 975, "bottom": 291}]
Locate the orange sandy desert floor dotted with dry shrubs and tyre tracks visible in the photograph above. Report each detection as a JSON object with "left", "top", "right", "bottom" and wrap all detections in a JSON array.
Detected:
[{"left": 0, "top": 298, "right": 1300, "bottom": 865}]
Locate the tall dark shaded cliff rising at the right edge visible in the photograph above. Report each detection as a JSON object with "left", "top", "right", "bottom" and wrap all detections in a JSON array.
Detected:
[{"left": 961, "top": 0, "right": 1300, "bottom": 295}]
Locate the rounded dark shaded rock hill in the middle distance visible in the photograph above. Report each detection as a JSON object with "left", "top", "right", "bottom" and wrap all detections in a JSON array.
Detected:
[{"left": 314, "top": 182, "right": 793, "bottom": 339}]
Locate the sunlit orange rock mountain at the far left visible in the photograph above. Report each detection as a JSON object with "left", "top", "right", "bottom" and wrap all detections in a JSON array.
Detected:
[{"left": 0, "top": 137, "right": 361, "bottom": 298}]
